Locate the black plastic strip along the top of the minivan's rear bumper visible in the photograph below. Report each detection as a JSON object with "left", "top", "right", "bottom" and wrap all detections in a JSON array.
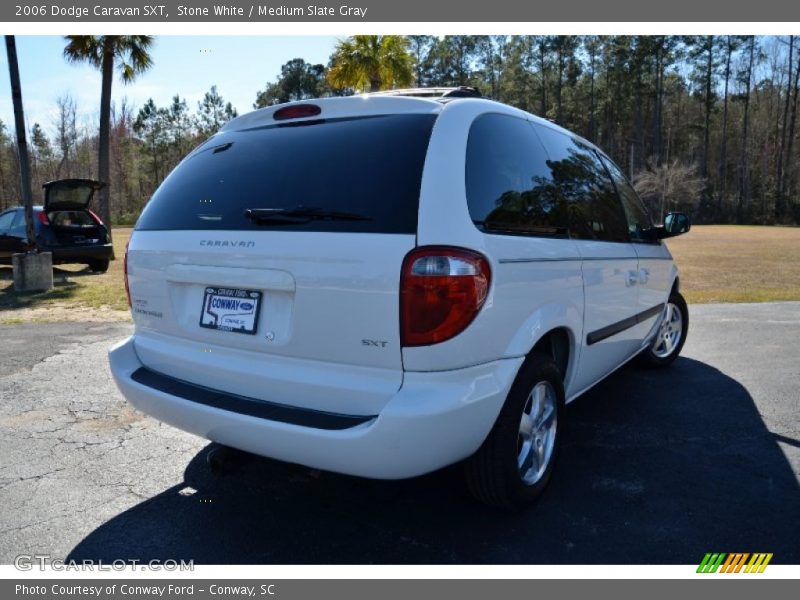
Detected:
[{"left": 131, "top": 367, "right": 377, "bottom": 430}]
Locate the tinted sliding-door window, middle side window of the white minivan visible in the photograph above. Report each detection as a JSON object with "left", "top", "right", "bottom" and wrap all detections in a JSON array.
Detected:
[{"left": 534, "top": 125, "right": 630, "bottom": 242}]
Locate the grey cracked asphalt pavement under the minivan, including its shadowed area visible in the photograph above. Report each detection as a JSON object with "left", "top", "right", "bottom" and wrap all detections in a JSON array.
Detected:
[{"left": 0, "top": 302, "right": 800, "bottom": 564}]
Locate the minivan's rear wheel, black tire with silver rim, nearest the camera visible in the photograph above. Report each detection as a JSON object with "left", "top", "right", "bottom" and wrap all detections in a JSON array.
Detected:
[{"left": 464, "top": 353, "right": 564, "bottom": 510}]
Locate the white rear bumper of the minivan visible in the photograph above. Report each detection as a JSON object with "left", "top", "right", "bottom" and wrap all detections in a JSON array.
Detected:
[{"left": 109, "top": 337, "right": 523, "bottom": 479}]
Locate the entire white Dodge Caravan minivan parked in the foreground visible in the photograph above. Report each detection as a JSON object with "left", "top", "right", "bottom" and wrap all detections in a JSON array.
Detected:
[{"left": 110, "top": 89, "right": 689, "bottom": 507}]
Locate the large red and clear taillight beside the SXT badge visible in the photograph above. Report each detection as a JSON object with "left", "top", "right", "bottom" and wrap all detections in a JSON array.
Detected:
[{"left": 400, "top": 246, "right": 491, "bottom": 346}]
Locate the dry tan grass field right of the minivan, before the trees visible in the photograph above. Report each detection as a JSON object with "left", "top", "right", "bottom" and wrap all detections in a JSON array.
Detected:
[{"left": 667, "top": 225, "right": 800, "bottom": 303}]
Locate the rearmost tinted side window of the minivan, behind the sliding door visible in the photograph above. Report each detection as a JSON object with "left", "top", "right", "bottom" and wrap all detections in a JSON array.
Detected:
[{"left": 466, "top": 114, "right": 568, "bottom": 235}]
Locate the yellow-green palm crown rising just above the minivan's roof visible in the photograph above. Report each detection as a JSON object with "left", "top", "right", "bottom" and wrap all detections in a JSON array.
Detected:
[{"left": 328, "top": 35, "right": 414, "bottom": 92}]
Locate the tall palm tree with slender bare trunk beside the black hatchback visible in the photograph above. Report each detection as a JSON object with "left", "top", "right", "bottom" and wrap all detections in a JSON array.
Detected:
[{"left": 64, "top": 35, "right": 153, "bottom": 235}]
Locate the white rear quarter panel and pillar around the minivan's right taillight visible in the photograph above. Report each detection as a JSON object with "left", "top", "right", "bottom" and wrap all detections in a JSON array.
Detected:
[{"left": 410, "top": 100, "right": 583, "bottom": 394}]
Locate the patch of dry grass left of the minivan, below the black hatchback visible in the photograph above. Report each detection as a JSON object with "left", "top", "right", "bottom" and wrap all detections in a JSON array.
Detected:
[{"left": 0, "top": 228, "right": 131, "bottom": 324}]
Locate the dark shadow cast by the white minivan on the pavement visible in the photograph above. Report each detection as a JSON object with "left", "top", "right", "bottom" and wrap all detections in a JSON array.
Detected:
[{"left": 69, "top": 358, "right": 800, "bottom": 564}]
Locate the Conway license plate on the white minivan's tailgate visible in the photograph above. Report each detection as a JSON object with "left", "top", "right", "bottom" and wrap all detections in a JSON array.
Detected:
[{"left": 200, "top": 287, "right": 261, "bottom": 335}]
